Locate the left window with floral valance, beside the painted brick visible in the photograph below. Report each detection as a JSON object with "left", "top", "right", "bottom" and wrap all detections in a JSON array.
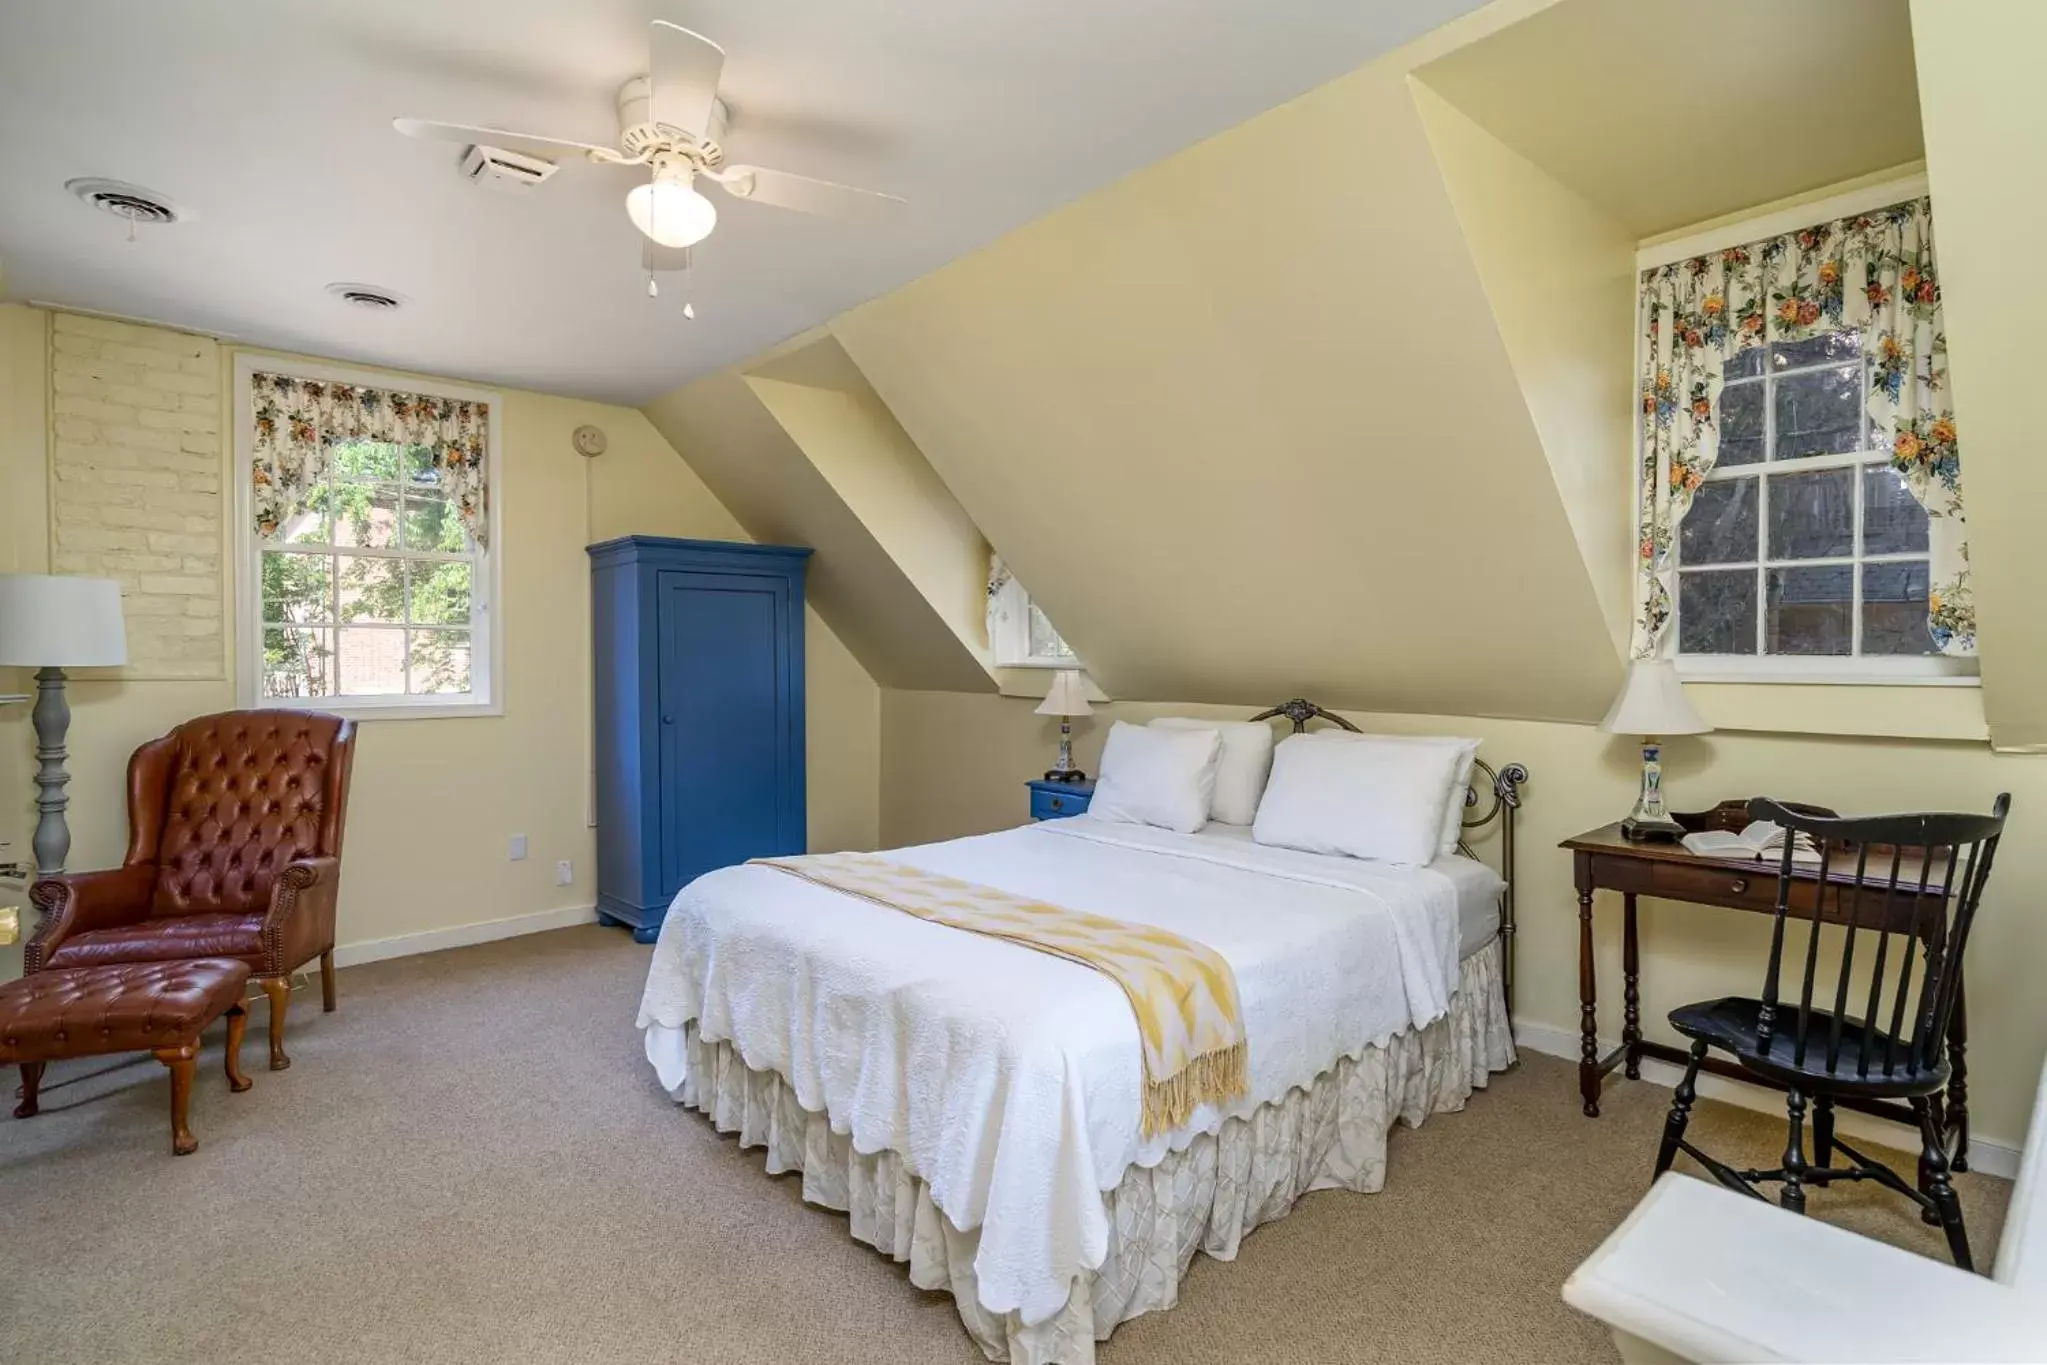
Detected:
[{"left": 237, "top": 364, "right": 499, "bottom": 716}]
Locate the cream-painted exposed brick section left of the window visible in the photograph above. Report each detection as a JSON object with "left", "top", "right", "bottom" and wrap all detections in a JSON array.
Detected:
[{"left": 49, "top": 313, "right": 227, "bottom": 677}]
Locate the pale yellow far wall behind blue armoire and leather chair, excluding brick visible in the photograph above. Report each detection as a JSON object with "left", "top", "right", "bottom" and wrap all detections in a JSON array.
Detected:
[{"left": 0, "top": 307, "right": 880, "bottom": 972}]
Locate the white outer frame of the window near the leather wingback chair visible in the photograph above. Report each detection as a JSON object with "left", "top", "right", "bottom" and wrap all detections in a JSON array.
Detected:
[{"left": 233, "top": 352, "right": 506, "bottom": 720}]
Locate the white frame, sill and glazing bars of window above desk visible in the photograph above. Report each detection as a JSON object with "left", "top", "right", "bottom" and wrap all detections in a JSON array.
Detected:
[{"left": 1629, "top": 174, "right": 1979, "bottom": 688}]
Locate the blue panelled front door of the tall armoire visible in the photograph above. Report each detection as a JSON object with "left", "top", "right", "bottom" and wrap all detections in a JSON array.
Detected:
[{"left": 657, "top": 571, "right": 802, "bottom": 898}]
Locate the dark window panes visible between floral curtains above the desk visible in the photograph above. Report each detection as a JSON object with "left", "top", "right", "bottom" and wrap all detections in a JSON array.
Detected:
[{"left": 1676, "top": 332, "right": 1936, "bottom": 659}]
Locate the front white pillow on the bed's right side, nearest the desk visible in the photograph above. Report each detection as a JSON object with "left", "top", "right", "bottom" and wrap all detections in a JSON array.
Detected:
[{"left": 1251, "top": 735, "right": 1457, "bottom": 868}]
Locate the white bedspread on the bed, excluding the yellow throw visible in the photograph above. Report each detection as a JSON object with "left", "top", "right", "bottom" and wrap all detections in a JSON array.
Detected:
[{"left": 639, "top": 817, "right": 1460, "bottom": 1322}]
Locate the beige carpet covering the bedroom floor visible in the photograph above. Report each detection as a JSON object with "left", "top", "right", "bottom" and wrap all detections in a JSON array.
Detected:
[{"left": 0, "top": 927, "right": 2008, "bottom": 1365}]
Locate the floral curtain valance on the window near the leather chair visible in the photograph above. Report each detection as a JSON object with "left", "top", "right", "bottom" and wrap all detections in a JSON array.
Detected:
[{"left": 250, "top": 372, "right": 489, "bottom": 546}]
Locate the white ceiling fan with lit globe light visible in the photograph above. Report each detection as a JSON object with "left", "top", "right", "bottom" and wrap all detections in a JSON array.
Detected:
[{"left": 391, "top": 18, "right": 903, "bottom": 282}]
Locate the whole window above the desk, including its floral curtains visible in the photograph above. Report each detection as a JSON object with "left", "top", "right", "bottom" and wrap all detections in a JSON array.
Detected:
[{"left": 1634, "top": 184, "right": 1975, "bottom": 681}]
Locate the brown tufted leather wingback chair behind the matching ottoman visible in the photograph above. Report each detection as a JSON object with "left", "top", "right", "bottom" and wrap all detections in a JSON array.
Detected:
[{"left": 23, "top": 710, "right": 356, "bottom": 1070}]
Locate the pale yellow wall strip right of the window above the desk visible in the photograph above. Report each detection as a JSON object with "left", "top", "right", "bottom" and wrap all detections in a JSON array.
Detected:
[{"left": 1912, "top": 0, "right": 2047, "bottom": 749}]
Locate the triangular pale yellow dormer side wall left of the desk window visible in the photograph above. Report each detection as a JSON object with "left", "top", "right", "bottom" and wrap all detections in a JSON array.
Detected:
[{"left": 1412, "top": 78, "right": 1636, "bottom": 649}]
